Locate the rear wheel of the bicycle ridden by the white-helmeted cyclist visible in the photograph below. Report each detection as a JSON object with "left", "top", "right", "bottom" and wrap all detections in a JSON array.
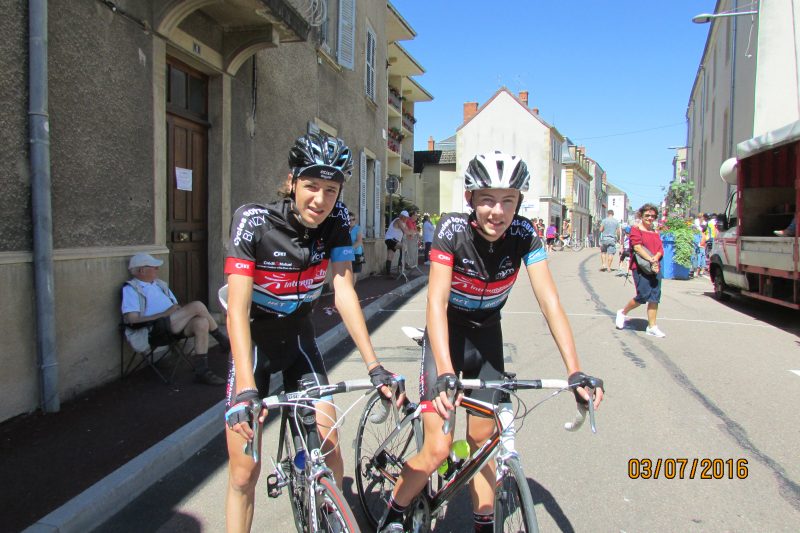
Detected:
[{"left": 355, "top": 392, "right": 418, "bottom": 527}]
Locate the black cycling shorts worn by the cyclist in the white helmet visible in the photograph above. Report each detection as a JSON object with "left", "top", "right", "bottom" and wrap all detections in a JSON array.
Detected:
[{"left": 419, "top": 322, "right": 504, "bottom": 403}]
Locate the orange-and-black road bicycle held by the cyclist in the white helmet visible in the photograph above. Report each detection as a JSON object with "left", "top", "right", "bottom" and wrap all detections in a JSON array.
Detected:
[{"left": 355, "top": 328, "right": 602, "bottom": 533}]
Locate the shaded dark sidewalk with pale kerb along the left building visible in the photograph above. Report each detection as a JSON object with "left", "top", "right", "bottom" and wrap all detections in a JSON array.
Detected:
[{"left": 0, "top": 267, "right": 427, "bottom": 531}]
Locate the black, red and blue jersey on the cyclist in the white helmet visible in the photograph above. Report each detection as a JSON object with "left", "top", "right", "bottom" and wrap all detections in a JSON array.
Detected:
[{"left": 430, "top": 212, "right": 547, "bottom": 327}]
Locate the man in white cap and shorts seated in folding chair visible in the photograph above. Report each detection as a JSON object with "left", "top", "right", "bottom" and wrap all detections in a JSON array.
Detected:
[{"left": 122, "top": 254, "right": 230, "bottom": 385}]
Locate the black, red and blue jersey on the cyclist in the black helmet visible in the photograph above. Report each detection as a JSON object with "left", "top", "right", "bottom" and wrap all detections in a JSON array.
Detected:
[{"left": 225, "top": 199, "right": 354, "bottom": 319}]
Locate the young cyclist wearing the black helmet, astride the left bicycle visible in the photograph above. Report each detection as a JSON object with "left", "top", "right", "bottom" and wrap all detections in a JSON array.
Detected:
[{"left": 225, "top": 134, "right": 400, "bottom": 532}]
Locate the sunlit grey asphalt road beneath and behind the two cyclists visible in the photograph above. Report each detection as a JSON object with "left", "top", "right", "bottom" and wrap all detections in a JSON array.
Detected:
[{"left": 99, "top": 249, "right": 800, "bottom": 532}]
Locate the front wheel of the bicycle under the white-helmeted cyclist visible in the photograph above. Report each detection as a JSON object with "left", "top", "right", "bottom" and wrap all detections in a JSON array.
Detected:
[{"left": 494, "top": 457, "right": 539, "bottom": 533}]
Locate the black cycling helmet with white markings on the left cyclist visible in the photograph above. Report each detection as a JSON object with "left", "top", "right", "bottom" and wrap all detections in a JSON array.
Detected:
[{"left": 289, "top": 133, "right": 353, "bottom": 184}]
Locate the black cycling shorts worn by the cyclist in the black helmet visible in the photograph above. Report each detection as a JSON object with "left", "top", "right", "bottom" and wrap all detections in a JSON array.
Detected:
[{"left": 225, "top": 317, "right": 328, "bottom": 409}]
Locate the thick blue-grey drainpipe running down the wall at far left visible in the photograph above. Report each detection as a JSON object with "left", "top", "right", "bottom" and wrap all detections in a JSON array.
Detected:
[{"left": 28, "top": 0, "right": 61, "bottom": 413}]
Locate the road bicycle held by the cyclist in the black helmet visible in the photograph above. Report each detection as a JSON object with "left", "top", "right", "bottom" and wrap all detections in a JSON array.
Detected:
[{"left": 245, "top": 379, "right": 380, "bottom": 533}]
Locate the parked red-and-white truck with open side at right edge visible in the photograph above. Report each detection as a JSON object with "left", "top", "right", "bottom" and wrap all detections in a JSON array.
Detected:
[{"left": 709, "top": 121, "right": 800, "bottom": 309}]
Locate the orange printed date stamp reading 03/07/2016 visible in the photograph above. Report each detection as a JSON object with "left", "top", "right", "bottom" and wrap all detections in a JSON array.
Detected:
[{"left": 628, "top": 457, "right": 748, "bottom": 479}]
